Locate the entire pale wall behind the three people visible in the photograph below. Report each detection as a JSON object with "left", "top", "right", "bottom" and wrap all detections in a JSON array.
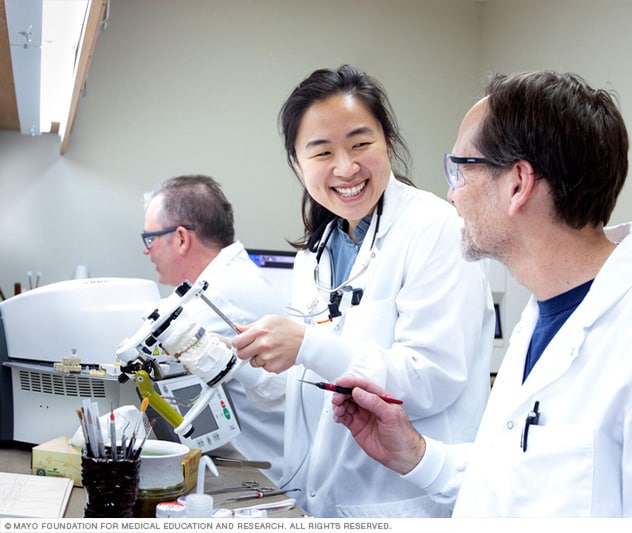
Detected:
[{"left": 0, "top": 0, "right": 632, "bottom": 296}]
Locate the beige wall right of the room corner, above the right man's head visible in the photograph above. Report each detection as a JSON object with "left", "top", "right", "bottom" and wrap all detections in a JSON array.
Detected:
[{"left": 480, "top": 0, "right": 632, "bottom": 224}]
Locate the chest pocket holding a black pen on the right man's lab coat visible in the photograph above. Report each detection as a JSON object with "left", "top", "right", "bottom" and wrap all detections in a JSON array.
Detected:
[{"left": 508, "top": 424, "right": 595, "bottom": 517}]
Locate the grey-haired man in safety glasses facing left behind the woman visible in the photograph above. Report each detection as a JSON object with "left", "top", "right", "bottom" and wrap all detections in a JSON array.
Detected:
[{"left": 141, "top": 175, "right": 285, "bottom": 482}]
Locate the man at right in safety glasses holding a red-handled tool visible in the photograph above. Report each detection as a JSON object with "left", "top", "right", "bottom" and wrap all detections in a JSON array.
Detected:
[{"left": 332, "top": 72, "right": 632, "bottom": 517}]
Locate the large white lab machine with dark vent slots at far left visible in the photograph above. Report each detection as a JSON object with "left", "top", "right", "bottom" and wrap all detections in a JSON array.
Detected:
[{"left": 0, "top": 278, "right": 160, "bottom": 444}]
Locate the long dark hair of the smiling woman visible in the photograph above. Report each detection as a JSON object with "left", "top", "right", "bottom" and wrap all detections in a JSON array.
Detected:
[{"left": 279, "top": 65, "right": 414, "bottom": 249}]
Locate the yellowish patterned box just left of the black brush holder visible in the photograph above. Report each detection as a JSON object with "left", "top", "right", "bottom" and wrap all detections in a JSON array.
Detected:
[{"left": 31, "top": 437, "right": 81, "bottom": 487}]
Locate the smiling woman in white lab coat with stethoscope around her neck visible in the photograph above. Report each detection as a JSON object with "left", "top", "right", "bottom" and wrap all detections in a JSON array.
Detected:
[{"left": 228, "top": 65, "right": 494, "bottom": 517}]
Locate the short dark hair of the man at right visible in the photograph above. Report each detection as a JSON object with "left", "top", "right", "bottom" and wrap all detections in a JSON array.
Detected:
[{"left": 475, "top": 72, "right": 628, "bottom": 229}]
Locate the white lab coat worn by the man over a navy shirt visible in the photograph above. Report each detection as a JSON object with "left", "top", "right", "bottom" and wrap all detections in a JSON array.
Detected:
[{"left": 410, "top": 221, "right": 632, "bottom": 517}]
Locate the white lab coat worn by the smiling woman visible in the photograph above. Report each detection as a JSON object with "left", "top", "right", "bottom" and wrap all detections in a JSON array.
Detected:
[{"left": 282, "top": 176, "right": 494, "bottom": 517}]
